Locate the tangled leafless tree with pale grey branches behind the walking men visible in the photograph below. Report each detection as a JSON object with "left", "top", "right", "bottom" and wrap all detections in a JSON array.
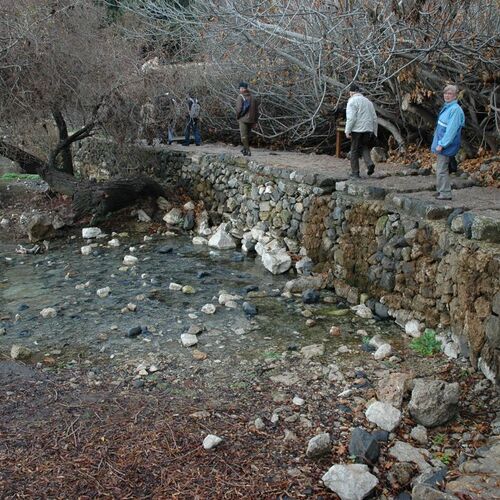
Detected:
[{"left": 121, "top": 0, "right": 500, "bottom": 150}]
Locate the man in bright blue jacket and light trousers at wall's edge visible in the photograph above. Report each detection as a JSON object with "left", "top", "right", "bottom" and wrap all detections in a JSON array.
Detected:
[{"left": 431, "top": 85, "right": 465, "bottom": 200}]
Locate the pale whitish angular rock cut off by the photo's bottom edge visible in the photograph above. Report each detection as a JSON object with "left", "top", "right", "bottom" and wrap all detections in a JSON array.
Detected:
[{"left": 321, "top": 464, "right": 378, "bottom": 500}]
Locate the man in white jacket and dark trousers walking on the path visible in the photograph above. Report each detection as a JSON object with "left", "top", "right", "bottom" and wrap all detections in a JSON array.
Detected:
[{"left": 345, "top": 83, "right": 378, "bottom": 179}]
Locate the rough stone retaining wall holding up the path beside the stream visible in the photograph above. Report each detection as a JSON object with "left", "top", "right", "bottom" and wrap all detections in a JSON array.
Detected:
[{"left": 75, "top": 143, "right": 500, "bottom": 383}]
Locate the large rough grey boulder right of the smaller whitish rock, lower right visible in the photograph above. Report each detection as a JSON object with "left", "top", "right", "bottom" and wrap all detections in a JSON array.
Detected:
[{"left": 408, "top": 379, "right": 460, "bottom": 427}]
